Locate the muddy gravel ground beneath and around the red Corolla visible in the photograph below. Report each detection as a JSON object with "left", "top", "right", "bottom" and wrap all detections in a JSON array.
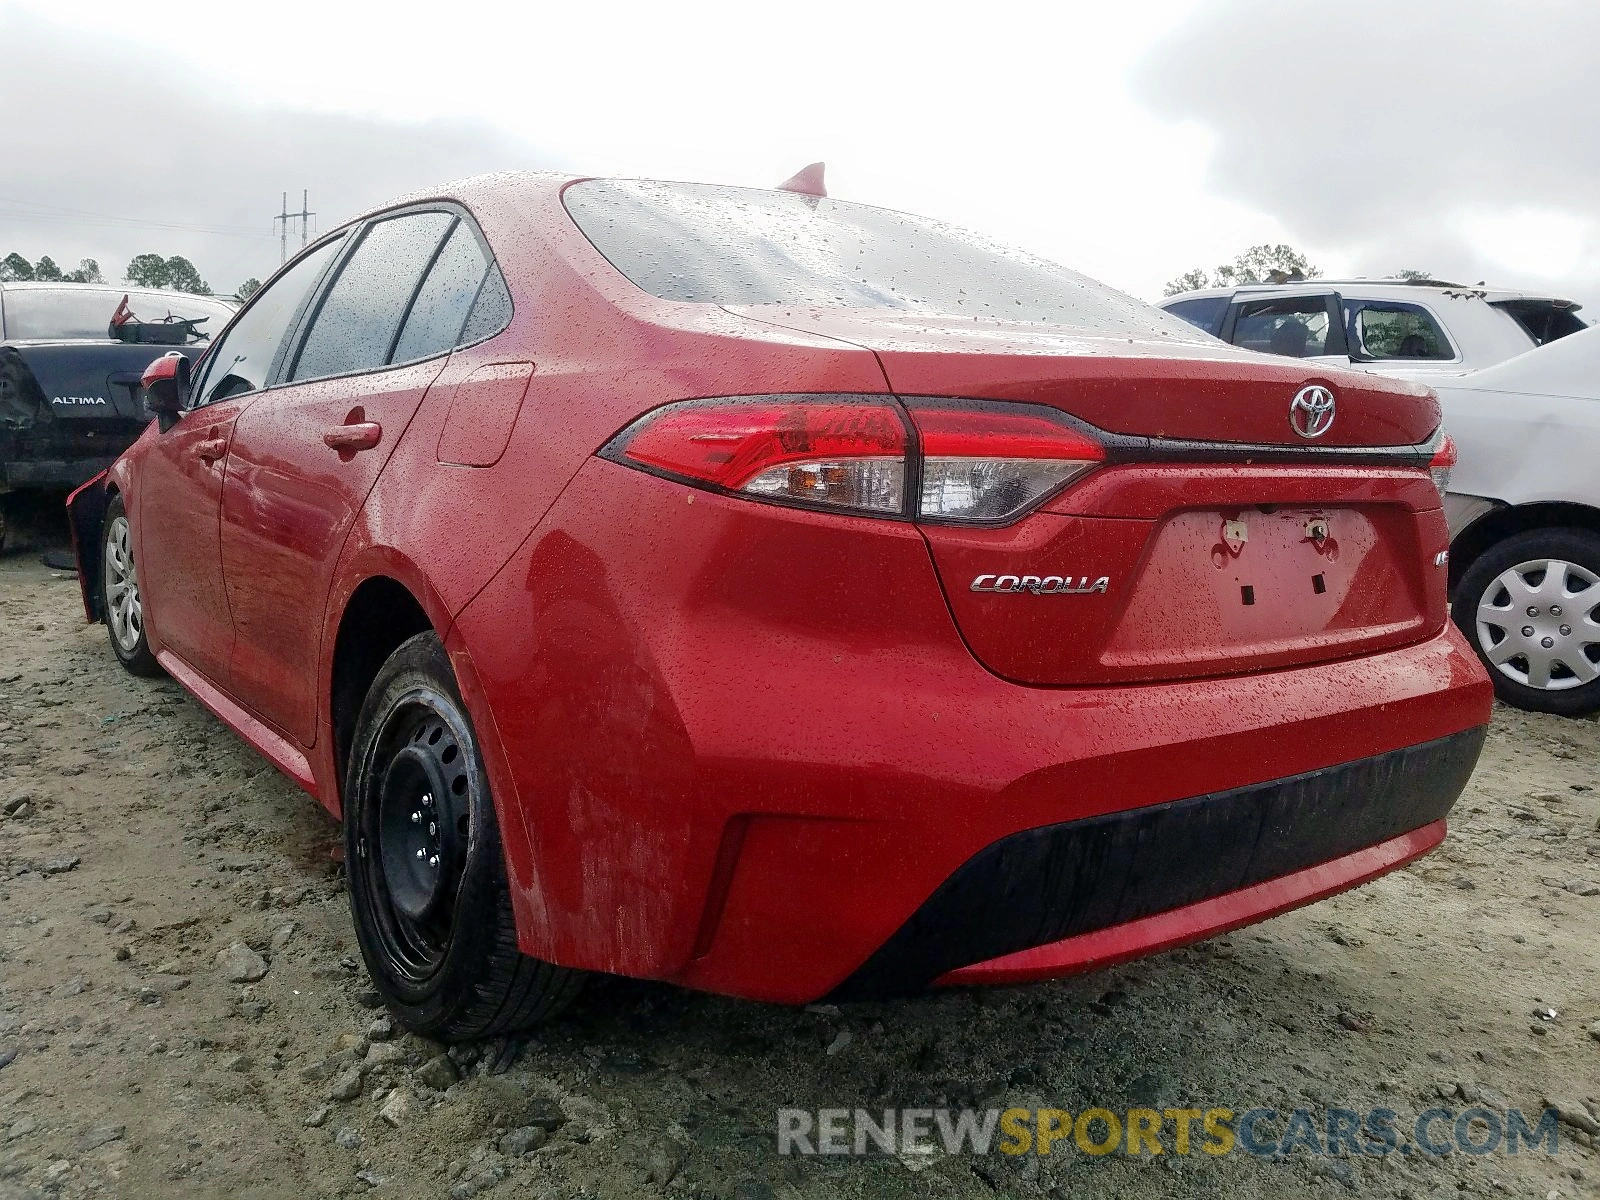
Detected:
[{"left": 0, "top": 557, "right": 1600, "bottom": 1200}]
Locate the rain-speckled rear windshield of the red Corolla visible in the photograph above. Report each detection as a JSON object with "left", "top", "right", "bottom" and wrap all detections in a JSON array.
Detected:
[{"left": 565, "top": 179, "right": 1194, "bottom": 341}]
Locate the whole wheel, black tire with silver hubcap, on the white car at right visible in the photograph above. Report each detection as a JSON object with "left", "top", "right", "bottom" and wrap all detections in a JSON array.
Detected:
[{"left": 1451, "top": 528, "right": 1600, "bottom": 717}]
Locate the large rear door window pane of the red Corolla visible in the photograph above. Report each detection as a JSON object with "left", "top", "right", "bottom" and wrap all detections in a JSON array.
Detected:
[{"left": 290, "top": 213, "right": 456, "bottom": 379}]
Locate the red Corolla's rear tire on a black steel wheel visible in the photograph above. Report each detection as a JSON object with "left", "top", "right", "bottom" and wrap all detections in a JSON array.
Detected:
[{"left": 344, "top": 632, "right": 584, "bottom": 1042}]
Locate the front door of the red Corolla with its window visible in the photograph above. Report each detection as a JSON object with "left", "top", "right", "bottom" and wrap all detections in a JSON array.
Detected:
[{"left": 133, "top": 238, "right": 341, "bottom": 686}]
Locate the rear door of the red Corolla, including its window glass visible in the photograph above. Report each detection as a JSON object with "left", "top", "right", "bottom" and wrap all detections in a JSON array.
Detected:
[{"left": 221, "top": 208, "right": 485, "bottom": 746}]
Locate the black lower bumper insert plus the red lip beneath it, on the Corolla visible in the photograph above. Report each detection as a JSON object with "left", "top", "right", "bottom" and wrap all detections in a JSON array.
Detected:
[{"left": 835, "top": 726, "right": 1483, "bottom": 1000}]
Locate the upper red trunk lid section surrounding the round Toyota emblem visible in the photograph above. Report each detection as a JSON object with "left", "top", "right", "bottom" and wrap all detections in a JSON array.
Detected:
[{"left": 730, "top": 306, "right": 1438, "bottom": 446}]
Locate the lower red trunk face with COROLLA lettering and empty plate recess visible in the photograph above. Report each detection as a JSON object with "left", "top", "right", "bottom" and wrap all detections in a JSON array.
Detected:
[{"left": 923, "top": 464, "right": 1450, "bottom": 685}]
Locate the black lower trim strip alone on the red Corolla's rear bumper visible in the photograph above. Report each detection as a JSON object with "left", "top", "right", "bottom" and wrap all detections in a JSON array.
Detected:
[{"left": 834, "top": 726, "right": 1486, "bottom": 1000}]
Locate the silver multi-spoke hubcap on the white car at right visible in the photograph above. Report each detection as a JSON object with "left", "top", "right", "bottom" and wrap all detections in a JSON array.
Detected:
[{"left": 1477, "top": 558, "right": 1600, "bottom": 691}]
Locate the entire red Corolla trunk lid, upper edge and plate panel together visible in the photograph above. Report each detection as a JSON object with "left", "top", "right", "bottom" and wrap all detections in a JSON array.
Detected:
[{"left": 744, "top": 307, "right": 1448, "bottom": 685}]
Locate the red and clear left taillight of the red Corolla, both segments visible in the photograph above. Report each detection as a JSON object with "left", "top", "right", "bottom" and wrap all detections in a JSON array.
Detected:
[{"left": 600, "top": 395, "right": 1106, "bottom": 523}]
